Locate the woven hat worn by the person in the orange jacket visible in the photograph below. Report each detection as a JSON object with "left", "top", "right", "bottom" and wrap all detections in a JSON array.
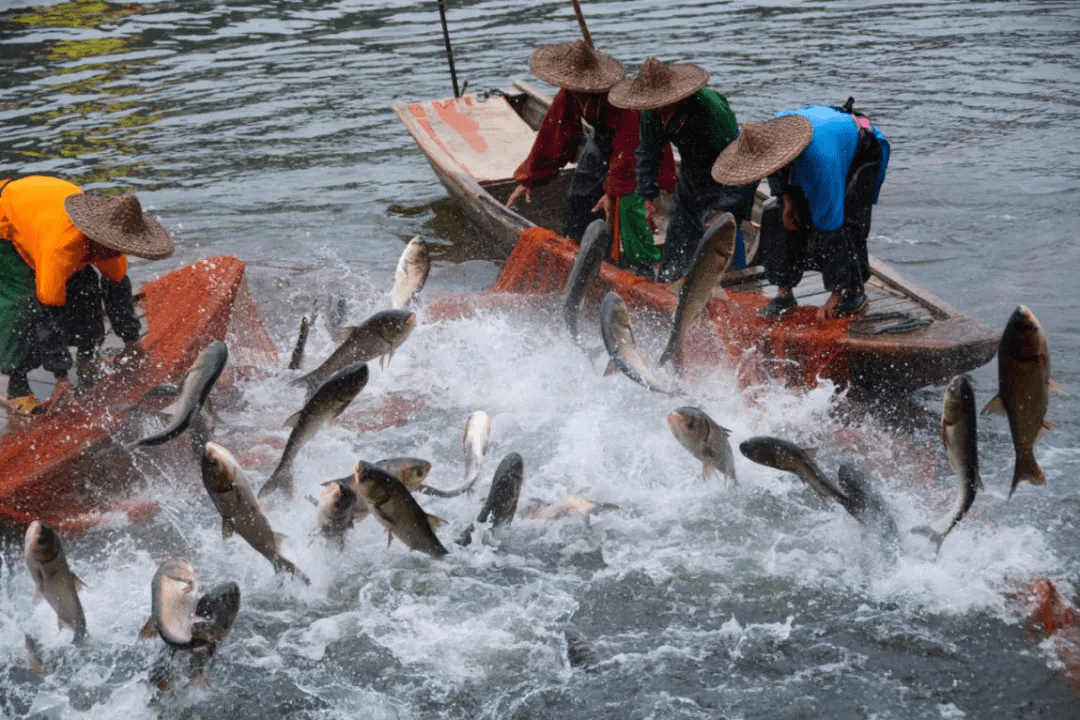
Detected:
[{"left": 64, "top": 192, "right": 173, "bottom": 260}]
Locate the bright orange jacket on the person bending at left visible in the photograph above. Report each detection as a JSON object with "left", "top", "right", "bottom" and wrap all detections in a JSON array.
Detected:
[{"left": 0, "top": 175, "right": 127, "bottom": 307}]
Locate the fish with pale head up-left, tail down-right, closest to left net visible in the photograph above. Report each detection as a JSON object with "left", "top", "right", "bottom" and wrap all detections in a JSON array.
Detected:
[{"left": 202, "top": 443, "right": 309, "bottom": 582}]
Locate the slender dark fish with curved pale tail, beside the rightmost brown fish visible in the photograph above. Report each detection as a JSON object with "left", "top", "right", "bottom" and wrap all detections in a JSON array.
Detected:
[{"left": 912, "top": 375, "right": 983, "bottom": 549}]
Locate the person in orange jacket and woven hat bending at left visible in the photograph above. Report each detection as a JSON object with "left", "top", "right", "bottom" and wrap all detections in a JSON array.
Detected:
[{"left": 0, "top": 175, "right": 173, "bottom": 413}]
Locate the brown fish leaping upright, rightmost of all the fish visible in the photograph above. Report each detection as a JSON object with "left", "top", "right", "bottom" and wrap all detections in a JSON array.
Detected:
[{"left": 983, "top": 305, "right": 1056, "bottom": 498}]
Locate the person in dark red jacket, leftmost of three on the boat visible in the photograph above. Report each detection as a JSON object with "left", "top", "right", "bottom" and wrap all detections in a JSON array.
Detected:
[{"left": 507, "top": 40, "right": 675, "bottom": 274}]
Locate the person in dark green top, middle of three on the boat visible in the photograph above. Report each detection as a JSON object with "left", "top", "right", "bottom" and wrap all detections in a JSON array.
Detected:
[{"left": 608, "top": 57, "right": 756, "bottom": 282}]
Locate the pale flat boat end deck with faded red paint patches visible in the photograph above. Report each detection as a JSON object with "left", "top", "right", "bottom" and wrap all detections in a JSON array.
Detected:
[{"left": 407, "top": 95, "right": 536, "bottom": 184}]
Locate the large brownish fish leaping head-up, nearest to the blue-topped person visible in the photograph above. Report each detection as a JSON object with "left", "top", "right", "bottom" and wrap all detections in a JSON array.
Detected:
[{"left": 657, "top": 213, "right": 738, "bottom": 367}]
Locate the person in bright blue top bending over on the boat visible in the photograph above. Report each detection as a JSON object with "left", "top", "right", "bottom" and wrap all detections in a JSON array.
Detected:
[{"left": 713, "top": 99, "right": 889, "bottom": 318}]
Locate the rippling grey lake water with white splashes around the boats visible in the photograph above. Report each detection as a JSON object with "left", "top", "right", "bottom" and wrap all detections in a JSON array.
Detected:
[{"left": 0, "top": 0, "right": 1080, "bottom": 720}]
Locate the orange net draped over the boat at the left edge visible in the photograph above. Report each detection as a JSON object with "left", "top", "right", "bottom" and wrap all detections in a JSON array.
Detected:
[{"left": 0, "top": 256, "right": 276, "bottom": 538}]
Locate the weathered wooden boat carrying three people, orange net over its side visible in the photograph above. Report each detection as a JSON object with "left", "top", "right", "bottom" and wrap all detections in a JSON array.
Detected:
[{"left": 393, "top": 82, "right": 1000, "bottom": 392}]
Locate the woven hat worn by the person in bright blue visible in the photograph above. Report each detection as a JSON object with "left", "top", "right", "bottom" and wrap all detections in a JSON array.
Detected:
[{"left": 713, "top": 114, "right": 813, "bottom": 186}]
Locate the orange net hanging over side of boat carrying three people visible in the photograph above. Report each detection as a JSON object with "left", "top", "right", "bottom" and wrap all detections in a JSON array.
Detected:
[{"left": 490, "top": 227, "right": 851, "bottom": 388}]
